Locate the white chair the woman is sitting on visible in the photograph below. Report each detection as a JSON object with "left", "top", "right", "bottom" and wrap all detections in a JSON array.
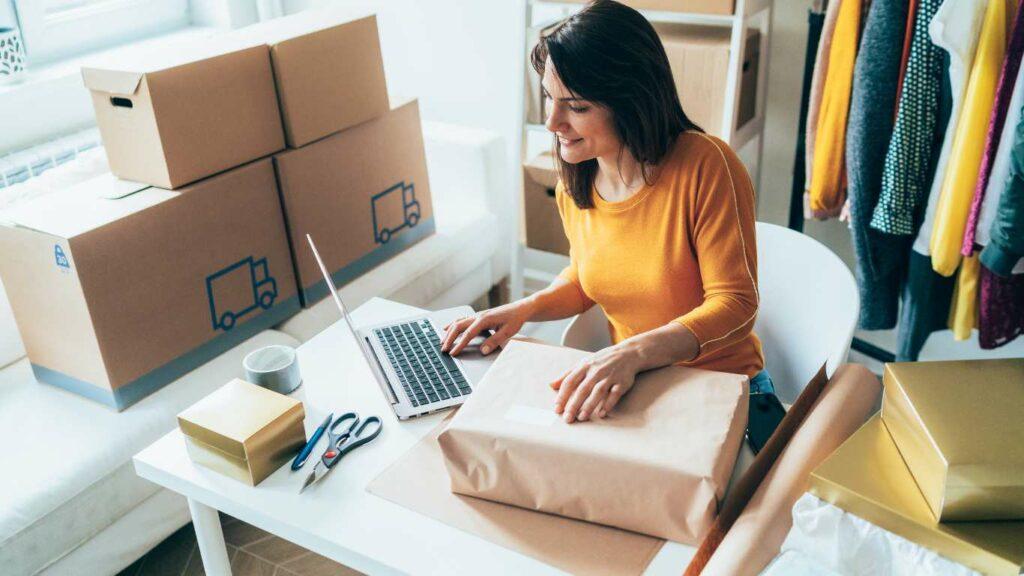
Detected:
[{"left": 561, "top": 222, "right": 860, "bottom": 404}]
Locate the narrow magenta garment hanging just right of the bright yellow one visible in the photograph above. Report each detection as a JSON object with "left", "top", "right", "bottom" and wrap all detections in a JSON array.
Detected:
[{"left": 961, "top": 0, "right": 1024, "bottom": 256}]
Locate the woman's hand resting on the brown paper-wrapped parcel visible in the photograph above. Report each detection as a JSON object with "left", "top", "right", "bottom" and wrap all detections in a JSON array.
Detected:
[{"left": 551, "top": 344, "right": 640, "bottom": 423}]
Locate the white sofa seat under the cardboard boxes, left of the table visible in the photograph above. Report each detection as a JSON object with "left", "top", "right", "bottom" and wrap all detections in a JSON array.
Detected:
[{"left": 0, "top": 330, "right": 299, "bottom": 574}]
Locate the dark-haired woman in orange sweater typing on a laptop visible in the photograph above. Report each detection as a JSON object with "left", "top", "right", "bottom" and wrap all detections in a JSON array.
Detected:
[{"left": 441, "top": 0, "right": 774, "bottom": 422}]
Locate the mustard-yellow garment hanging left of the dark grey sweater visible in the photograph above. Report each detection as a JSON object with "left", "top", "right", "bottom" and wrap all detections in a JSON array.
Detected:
[{"left": 808, "top": 0, "right": 861, "bottom": 216}]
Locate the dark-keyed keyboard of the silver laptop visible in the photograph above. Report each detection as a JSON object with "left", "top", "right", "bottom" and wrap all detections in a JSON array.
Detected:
[{"left": 374, "top": 319, "right": 472, "bottom": 406}]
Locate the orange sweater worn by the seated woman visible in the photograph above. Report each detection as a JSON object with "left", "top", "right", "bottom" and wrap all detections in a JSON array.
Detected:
[{"left": 556, "top": 132, "right": 764, "bottom": 376}]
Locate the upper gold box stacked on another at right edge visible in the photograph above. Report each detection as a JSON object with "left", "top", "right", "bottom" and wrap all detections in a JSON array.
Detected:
[{"left": 882, "top": 360, "right": 1024, "bottom": 522}]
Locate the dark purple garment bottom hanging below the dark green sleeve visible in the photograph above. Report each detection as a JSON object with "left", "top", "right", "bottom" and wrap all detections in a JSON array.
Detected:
[{"left": 978, "top": 266, "right": 1024, "bottom": 349}]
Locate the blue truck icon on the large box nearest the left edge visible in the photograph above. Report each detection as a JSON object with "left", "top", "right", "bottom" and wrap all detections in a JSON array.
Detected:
[{"left": 206, "top": 256, "right": 278, "bottom": 331}]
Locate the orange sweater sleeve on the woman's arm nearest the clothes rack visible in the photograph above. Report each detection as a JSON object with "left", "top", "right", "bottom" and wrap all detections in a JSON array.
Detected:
[{"left": 673, "top": 140, "right": 759, "bottom": 358}]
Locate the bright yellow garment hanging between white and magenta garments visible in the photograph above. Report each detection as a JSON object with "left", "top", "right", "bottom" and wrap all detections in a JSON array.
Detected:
[{"left": 931, "top": 0, "right": 1014, "bottom": 276}]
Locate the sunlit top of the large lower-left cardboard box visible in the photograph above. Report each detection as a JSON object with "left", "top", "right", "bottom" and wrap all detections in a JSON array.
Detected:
[{"left": 0, "top": 173, "right": 167, "bottom": 238}]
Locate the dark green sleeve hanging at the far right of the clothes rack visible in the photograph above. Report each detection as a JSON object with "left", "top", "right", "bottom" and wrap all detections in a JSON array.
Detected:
[{"left": 980, "top": 113, "right": 1024, "bottom": 276}]
